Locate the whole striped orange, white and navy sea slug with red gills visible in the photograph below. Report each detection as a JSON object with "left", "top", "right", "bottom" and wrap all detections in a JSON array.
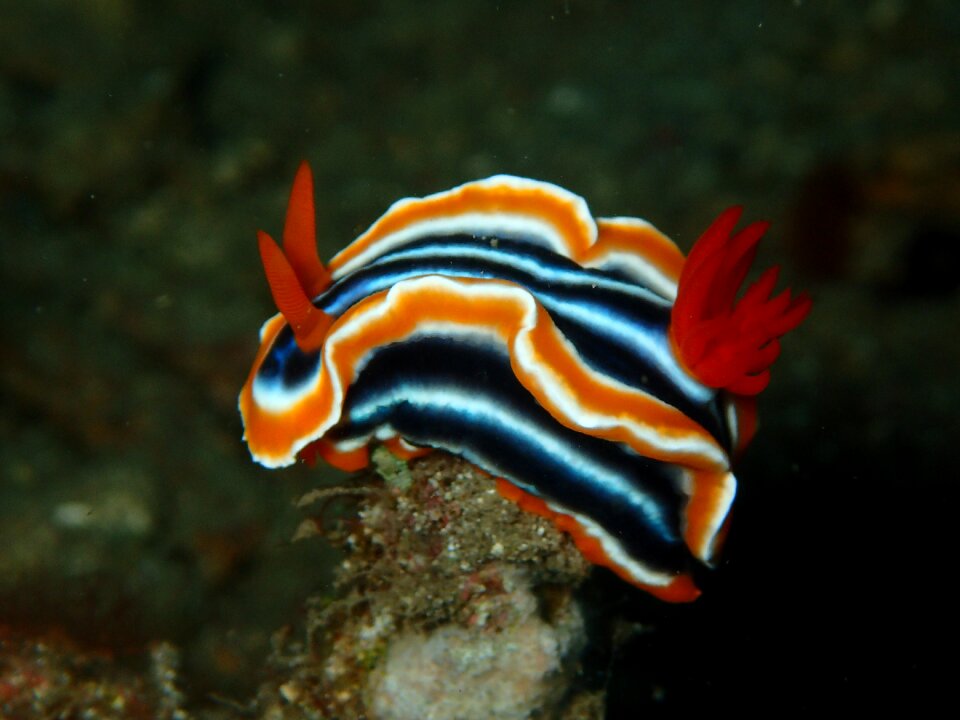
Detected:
[{"left": 240, "top": 163, "right": 811, "bottom": 601}]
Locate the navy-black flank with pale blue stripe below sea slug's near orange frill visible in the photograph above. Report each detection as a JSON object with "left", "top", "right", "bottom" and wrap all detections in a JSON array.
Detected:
[{"left": 327, "top": 337, "right": 696, "bottom": 571}]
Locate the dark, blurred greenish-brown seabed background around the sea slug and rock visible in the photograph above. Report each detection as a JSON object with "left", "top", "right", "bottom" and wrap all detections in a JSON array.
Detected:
[{"left": 0, "top": 0, "right": 960, "bottom": 718}]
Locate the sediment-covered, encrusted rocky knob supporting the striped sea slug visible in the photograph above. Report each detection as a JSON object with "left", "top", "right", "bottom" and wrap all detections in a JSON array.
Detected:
[{"left": 253, "top": 453, "right": 603, "bottom": 720}]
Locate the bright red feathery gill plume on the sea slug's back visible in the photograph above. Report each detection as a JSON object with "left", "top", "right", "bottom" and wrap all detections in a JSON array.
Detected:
[{"left": 670, "top": 207, "right": 812, "bottom": 395}]
